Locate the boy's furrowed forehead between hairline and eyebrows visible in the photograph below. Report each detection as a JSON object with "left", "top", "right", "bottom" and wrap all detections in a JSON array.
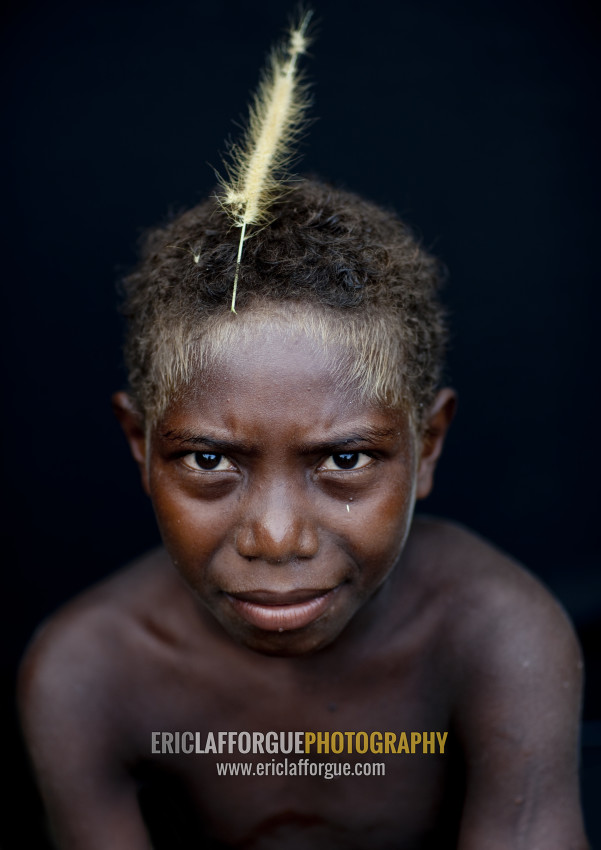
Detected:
[{"left": 159, "top": 318, "right": 406, "bottom": 440}]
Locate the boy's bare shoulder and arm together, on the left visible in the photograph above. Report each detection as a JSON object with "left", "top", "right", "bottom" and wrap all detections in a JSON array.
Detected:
[{"left": 18, "top": 555, "right": 176, "bottom": 850}]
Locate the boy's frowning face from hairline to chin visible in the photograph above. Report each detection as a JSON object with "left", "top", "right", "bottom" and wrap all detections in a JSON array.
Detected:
[{"left": 116, "top": 320, "right": 452, "bottom": 655}]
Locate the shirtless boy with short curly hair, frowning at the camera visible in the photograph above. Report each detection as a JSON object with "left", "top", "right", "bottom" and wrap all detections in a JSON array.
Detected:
[{"left": 21, "top": 180, "right": 587, "bottom": 850}]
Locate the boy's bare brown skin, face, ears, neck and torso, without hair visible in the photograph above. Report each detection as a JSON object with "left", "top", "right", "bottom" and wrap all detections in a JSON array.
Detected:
[{"left": 20, "top": 328, "right": 587, "bottom": 850}]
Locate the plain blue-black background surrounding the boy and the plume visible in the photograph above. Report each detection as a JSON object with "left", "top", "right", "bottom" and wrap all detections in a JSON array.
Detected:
[{"left": 0, "top": 0, "right": 601, "bottom": 848}]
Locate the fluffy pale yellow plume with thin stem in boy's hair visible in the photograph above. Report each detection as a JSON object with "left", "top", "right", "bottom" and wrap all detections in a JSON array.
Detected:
[{"left": 219, "top": 12, "right": 312, "bottom": 313}]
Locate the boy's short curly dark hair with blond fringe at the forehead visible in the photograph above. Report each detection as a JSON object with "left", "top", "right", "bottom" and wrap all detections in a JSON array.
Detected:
[{"left": 123, "top": 179, "right": 447, "bottom": 426}]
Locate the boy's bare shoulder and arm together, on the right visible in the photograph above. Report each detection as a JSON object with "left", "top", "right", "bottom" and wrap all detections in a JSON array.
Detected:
[{"left": 408, "top": 520, "right": 588, "bottom": 850}]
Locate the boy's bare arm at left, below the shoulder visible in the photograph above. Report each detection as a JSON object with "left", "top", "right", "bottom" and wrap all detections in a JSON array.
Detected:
[{"left": 19, "top": 618, "right": 151, "bottom": 850}]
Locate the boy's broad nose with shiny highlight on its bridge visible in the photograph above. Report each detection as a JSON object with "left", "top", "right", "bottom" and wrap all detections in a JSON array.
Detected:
[{"left": 236, "top": 488, "right": 319, "bottom": 564}]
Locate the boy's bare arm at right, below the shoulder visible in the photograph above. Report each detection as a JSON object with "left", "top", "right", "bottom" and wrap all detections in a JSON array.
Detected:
[{"left": 455, "top": 575, "right": 588, "bottom": 850}]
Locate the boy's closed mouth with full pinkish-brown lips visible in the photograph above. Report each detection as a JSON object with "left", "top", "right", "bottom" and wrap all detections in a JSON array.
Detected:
[{"left": 225, "top": 585, "right": 340, "bottom": 632}]
